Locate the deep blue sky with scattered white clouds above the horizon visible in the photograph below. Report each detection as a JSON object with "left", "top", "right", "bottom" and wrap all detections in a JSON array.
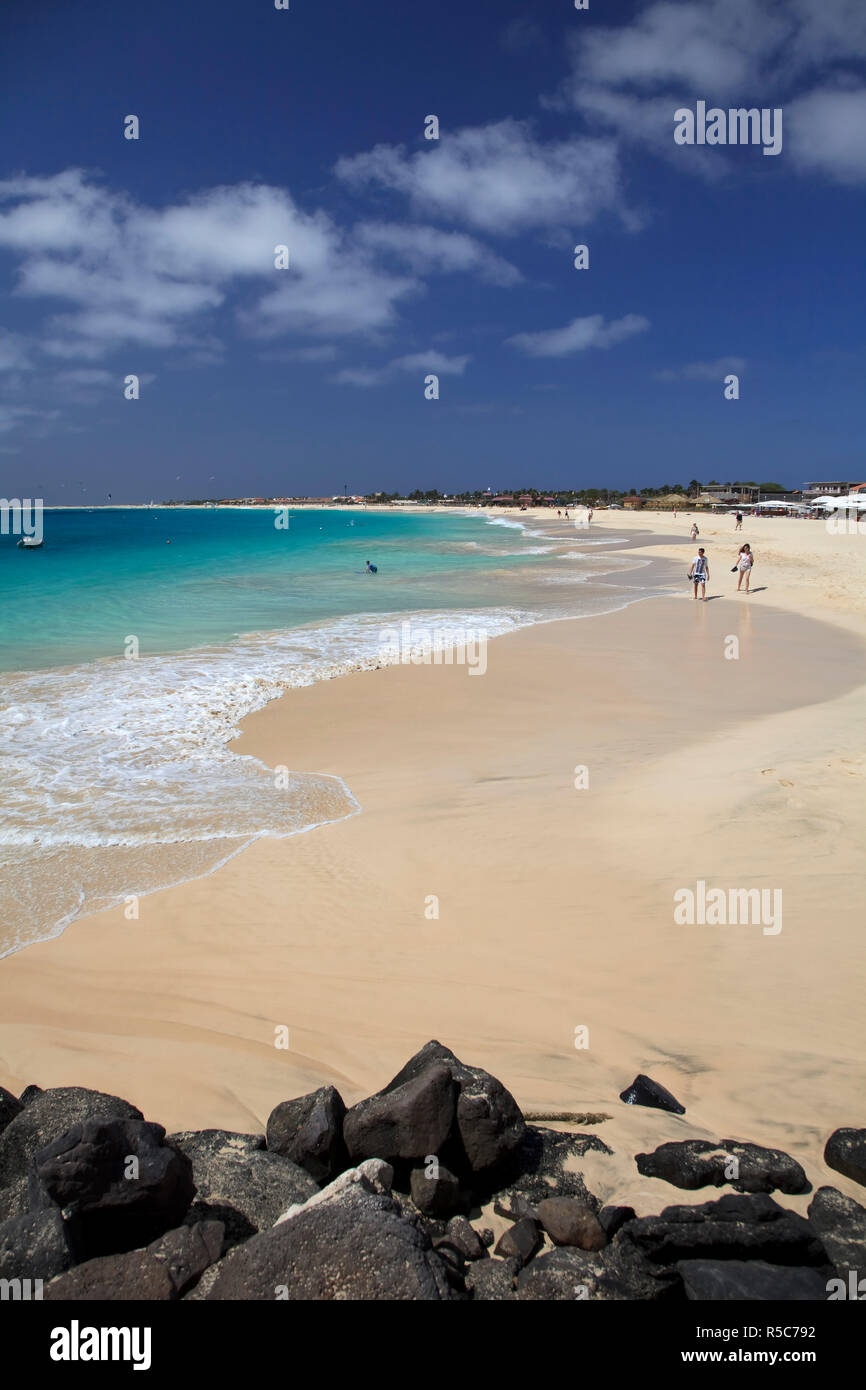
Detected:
[{"left": 0, "top": 0, "right": 866, "bottom": 505}]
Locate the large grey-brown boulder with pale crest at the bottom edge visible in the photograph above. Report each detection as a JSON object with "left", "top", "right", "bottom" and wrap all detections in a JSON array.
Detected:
[{"left": 207, "top": 1170, "right": 452, "bottom": 1302}]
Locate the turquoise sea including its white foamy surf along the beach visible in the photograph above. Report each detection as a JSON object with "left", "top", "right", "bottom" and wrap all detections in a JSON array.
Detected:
[{"left": 0, "top": 506, "right": 648, "bottom": 955}]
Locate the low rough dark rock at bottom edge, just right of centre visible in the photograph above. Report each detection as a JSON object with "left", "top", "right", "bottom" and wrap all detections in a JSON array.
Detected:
[{"left": 516, "top": 1244, "right": 683, "bottom": 1302}]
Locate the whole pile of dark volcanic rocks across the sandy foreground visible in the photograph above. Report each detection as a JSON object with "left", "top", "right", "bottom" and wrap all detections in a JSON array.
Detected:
[{"left": 0, "top": 1043, "right": 866, "bottom": 1302}]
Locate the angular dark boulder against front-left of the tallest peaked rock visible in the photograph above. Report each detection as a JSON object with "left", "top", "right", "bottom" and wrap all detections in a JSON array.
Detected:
[{"left": 343, "top": 1062, "right": 456, "bottom": 1163}]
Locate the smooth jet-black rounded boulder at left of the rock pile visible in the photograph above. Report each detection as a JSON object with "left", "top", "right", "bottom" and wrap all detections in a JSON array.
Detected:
[{"left": 25, "top": 1112, "right": 195, "bottom": 1259}]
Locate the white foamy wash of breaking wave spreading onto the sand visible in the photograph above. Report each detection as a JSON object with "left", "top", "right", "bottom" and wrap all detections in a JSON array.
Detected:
[{"left": 0, "top": 609, "right": 534, "bottom": 955}]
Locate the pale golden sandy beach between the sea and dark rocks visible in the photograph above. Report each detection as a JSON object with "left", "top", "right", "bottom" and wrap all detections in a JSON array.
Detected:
[{"left": 0, "top": 512, "right": 866, "bottom": 1211}]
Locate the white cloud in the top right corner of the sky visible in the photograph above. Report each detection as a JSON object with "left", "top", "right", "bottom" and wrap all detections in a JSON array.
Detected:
[{"left": 558, "top": 0, "right": 866, "bottom": 183}]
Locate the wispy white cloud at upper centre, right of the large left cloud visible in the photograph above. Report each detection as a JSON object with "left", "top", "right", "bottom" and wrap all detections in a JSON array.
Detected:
[{"left": 336, "top": 120, "right": 620, "bottom": 235}]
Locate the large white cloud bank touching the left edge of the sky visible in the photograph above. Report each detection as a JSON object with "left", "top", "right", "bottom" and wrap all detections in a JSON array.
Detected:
[{"left": 0, "top": 170, "right": 423, "bottom": 361}]
